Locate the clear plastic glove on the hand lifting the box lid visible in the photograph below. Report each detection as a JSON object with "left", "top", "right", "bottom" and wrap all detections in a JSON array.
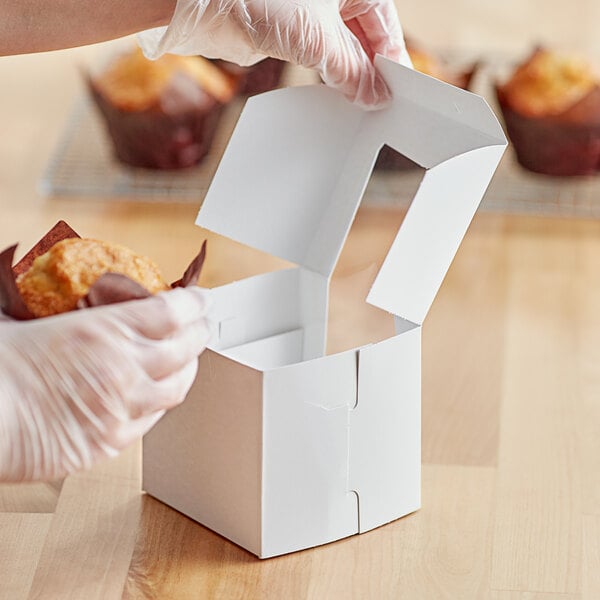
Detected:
[{"left": 139, "top": 0, "right": 410, "bottom": 108}]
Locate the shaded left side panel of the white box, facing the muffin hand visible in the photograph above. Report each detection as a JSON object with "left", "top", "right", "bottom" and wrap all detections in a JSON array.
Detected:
[{"left": 143, "top": 350, "right": 262, "bottom": 555}]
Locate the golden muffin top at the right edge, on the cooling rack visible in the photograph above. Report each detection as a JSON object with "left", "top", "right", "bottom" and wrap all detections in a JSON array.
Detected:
[{"left": 499, "top": 49, "right": 598, "bottom": 117}]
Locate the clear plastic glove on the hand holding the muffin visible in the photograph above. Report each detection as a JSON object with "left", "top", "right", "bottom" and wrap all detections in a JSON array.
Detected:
[{"left": 0, "top": 288, "right": 210, "bottom": 481}]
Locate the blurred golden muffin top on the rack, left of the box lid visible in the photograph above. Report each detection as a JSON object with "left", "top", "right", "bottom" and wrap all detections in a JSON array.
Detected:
[{"left": 94, "top": 48, "right": 235, "bottom": 112}]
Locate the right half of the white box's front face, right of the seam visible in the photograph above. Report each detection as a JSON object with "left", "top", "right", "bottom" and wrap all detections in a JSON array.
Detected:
[{"left": 349, "top": 327, "right": 421, "bottom": 533}]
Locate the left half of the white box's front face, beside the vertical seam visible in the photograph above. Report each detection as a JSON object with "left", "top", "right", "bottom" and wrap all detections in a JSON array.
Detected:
[{"left": 262, "top": 351, "right": 358, "bottom": 557}]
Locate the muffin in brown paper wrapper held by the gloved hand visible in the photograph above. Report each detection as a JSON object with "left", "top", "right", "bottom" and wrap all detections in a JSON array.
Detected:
[{"left": 0, "top": 221, "right": 206, "bottom": 320}]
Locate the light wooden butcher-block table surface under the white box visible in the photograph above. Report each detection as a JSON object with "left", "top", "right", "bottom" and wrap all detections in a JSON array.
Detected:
[{"left": 0, "top": 17, "right": 600, "bottom": 600}]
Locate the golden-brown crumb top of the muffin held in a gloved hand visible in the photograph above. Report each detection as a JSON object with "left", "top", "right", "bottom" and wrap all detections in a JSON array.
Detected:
[{"left": 17, "top": 238, "right": 169, "bottom": 317}]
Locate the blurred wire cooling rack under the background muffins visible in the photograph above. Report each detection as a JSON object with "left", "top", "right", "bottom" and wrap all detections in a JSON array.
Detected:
[{"left": 40, "top": 63, "right": 600, "bottom": 218}]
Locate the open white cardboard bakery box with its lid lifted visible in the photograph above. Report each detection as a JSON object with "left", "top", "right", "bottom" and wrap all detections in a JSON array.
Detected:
[{"left": 143, "top": 57, "right": 506, "bottom": 558}]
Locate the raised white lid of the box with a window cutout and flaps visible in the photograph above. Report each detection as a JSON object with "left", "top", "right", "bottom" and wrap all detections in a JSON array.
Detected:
[{"left": 196, "top": 56, "right": 506, "bottom": 324}]
